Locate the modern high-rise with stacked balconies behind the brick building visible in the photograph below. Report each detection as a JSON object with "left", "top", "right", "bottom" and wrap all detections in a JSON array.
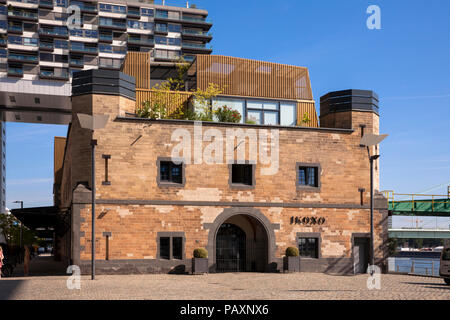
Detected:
[{"left": 0, "top": 0, "right": 212, "bottom": 124}]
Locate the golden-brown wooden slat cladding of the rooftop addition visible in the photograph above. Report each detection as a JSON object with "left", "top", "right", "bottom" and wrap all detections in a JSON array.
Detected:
[{"left": 121, "top": 52, "right": 319, "bottom": 127}]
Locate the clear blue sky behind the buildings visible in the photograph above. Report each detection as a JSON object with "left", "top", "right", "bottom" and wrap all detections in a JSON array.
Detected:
[{"left": 7, "top": 0, "right": 450, "bottom": 208}]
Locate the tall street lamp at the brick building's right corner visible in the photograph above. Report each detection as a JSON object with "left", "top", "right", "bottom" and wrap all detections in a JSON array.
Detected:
[{"left": 359, "top": 133, "right": 388, "bottom": 274}]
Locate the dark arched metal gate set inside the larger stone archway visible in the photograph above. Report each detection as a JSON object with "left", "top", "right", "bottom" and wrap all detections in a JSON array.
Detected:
[{"left": 216, "top": 223, "right": 246, "bottom": 272}]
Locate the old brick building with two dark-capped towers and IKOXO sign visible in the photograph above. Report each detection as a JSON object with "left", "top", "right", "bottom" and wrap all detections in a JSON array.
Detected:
[{"left": 55, "top": 56, "right": 387, "bottom": 274}]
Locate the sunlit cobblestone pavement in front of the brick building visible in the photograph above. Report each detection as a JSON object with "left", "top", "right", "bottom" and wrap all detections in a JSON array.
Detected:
[{"left": 0, "top": 273, "right": 450, "bottom": 300}]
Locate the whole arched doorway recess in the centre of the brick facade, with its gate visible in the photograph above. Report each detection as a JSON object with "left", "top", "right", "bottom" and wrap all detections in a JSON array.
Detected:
[{"left": 215, "top": 214, "right": 268, "bottom": 272}]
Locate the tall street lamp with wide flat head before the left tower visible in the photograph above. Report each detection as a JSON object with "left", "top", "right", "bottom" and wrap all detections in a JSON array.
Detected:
[{"left": 77, "top": 113, "right": 109, "bottom": 280}]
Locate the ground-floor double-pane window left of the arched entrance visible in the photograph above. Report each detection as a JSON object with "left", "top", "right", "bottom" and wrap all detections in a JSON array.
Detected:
[{"left": 157, "top": 232, "right": 185, "bottom": 260}]
